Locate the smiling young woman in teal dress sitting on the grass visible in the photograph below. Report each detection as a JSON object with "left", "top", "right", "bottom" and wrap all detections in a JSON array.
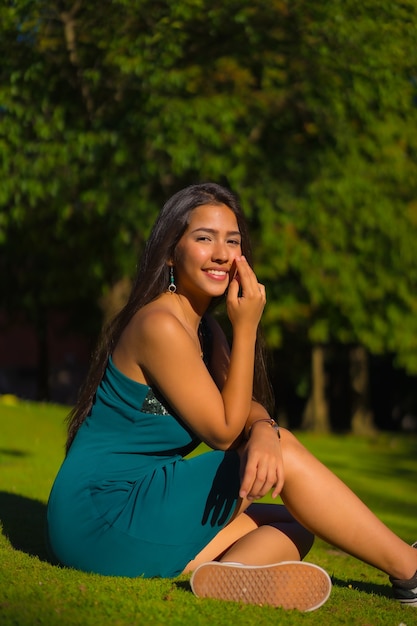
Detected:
[{"left": 48, "top": 183, "right": 417, "bottom": 610}]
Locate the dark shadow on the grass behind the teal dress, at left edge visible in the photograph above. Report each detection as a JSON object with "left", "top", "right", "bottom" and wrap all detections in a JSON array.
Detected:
[{"left": 0, "top": 491, "right": 54, "bottom": 564}]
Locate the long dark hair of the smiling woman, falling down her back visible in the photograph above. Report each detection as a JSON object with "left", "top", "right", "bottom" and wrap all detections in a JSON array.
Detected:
[{"left": 66, "top": 183, "right": 272, "bottom": 452}]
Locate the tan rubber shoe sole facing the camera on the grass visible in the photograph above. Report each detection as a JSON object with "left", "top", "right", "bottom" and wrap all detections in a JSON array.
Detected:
[{"left": 190, "top": 561, "right": 332, "bottom": 611}]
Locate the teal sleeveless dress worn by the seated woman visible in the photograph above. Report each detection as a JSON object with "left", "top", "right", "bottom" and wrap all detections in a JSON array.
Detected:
[{"left": 47, "top": 358, "right": 240, "bottom": 577}]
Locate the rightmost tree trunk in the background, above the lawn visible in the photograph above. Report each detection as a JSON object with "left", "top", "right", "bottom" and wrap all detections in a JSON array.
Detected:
[{"left": 349, "top": 346, "right": 376, "bottom": 435}]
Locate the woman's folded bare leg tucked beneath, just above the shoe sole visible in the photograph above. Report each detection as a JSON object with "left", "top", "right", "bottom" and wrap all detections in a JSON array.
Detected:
[{"left": 184, "top": 503, "right": 314, "bottom": 572}]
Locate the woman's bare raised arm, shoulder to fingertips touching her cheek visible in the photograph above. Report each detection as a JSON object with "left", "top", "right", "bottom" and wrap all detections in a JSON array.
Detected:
[{"left": 136, "top": 257, "right": 265, "bottom": 449}]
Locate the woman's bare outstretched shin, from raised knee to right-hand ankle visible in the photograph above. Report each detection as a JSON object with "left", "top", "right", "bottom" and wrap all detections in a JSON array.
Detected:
[{"left": 281, "top": 429, "right": 417, "bottom": 578}]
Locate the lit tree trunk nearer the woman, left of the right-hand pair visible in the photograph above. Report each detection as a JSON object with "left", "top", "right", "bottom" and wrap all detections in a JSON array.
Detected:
[{"left": 302, "top": 344, "right": 330, "bottom": 432}]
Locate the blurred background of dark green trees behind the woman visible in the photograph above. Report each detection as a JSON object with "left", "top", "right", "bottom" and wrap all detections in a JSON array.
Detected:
[{"left": 0, "top": 0, "right": 417, "bottom": 433}]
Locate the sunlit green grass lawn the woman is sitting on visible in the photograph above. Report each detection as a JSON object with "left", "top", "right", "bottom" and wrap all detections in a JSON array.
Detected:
[{"left": 0, "top": 397, "right": 417, "bottom": 626}]
